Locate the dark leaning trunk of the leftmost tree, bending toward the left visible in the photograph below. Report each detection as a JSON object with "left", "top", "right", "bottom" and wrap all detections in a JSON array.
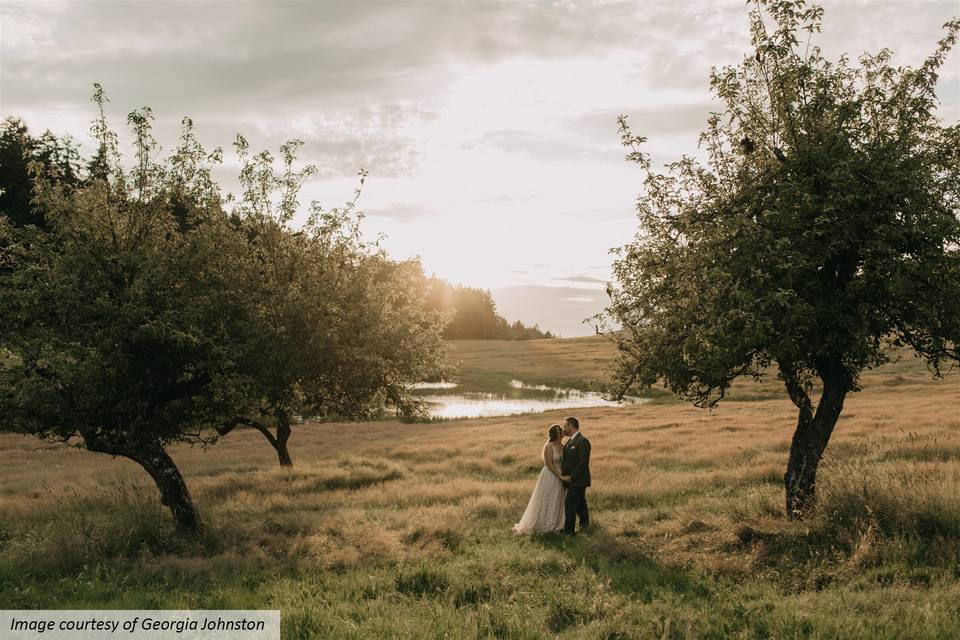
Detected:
[{"left": 84, "top": 435, "right": 203, "bottom": 535}]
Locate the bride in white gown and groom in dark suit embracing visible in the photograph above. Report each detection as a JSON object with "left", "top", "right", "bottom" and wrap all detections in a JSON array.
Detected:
[{"left": 513, "top": 418, "right": 590, "bottom": 535}]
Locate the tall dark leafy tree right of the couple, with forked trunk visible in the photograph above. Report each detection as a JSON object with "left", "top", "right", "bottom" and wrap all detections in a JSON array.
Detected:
[{"left": 600, "top": 0, "right": 960, "bottom": 517}]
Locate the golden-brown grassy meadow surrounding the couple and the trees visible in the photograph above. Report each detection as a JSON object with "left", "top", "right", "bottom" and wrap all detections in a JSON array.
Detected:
[{"left": 0, "top": 338, "right": 960, "bottom": 640}]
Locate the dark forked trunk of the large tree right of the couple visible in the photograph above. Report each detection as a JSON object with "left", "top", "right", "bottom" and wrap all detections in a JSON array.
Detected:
[{"left": 781, "top": 363, "right": 848, "bottom": 518}]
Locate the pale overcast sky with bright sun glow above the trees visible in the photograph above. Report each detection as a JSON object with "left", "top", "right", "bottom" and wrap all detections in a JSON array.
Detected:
[{"left": 0, "top": 0, "right": 960, "bottom": 336}]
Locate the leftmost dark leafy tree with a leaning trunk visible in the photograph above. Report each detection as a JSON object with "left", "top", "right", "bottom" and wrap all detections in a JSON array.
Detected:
[{"left": 0, "top": 86, "right": 254, "bottom": 533}]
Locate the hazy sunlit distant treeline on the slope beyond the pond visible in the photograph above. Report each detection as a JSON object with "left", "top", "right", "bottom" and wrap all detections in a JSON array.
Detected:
[{"left": 428, "top": 276, "right": 554, "bottom": 340}]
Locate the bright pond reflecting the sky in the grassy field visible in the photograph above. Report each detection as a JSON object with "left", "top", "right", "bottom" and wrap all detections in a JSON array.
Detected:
[{"left": 414, "top": 380, "right": 649, "bottom": 418}]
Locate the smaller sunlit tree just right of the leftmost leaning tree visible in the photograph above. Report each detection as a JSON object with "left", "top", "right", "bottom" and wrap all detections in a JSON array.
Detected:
[{"left": 218, "top": 137, "right": 443, "bottom": 466}]
